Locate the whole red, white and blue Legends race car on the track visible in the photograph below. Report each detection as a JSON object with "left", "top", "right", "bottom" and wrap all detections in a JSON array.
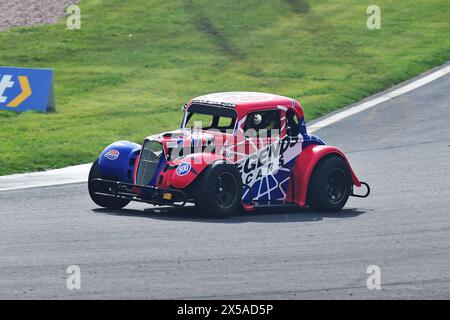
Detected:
[{"left": 88, "top": 92, "right": 370, "bottom": 217}]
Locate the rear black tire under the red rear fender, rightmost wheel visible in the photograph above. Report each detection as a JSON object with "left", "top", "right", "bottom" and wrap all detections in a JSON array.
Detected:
[{"left": 308, "top": 155, "right": 352, "bottom": 212}]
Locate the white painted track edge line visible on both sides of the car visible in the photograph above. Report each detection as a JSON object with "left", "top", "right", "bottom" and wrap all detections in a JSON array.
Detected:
[{"left": 0, "top": 65, "right": 450, "bottom": 191}]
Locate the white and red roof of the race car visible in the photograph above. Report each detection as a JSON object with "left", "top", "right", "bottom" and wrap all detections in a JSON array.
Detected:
[{"left": 189, "top": 91, "right": 298, "bottom": 113}]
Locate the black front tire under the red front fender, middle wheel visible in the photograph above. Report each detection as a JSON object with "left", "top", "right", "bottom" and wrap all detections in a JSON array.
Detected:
[{"left": 193, "top": 162, "right": 242, "bottom": 218}]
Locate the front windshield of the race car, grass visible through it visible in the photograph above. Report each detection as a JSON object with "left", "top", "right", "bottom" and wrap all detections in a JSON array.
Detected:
[{"left": 185, "top": 104, "right": 236, "bottom": 132}]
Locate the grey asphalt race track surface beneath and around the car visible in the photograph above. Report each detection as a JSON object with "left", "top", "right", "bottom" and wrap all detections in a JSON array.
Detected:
[{"left": 0, "top": 75, "right": 450, "bottom": 299}]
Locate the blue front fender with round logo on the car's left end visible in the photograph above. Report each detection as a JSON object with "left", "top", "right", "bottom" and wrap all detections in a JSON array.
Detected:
[{"left": 98, "top": 141, "right": 141, "bottom": 183}]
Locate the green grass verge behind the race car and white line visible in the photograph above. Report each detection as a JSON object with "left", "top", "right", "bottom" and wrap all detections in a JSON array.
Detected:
[{"left": 0, "top": 0, "right": 450, "bottom": 175}]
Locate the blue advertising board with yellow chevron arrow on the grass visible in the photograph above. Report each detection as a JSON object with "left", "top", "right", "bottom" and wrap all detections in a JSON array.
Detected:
[{"left": 0, "top": 67, "right": 55, "bottom": 112}]
